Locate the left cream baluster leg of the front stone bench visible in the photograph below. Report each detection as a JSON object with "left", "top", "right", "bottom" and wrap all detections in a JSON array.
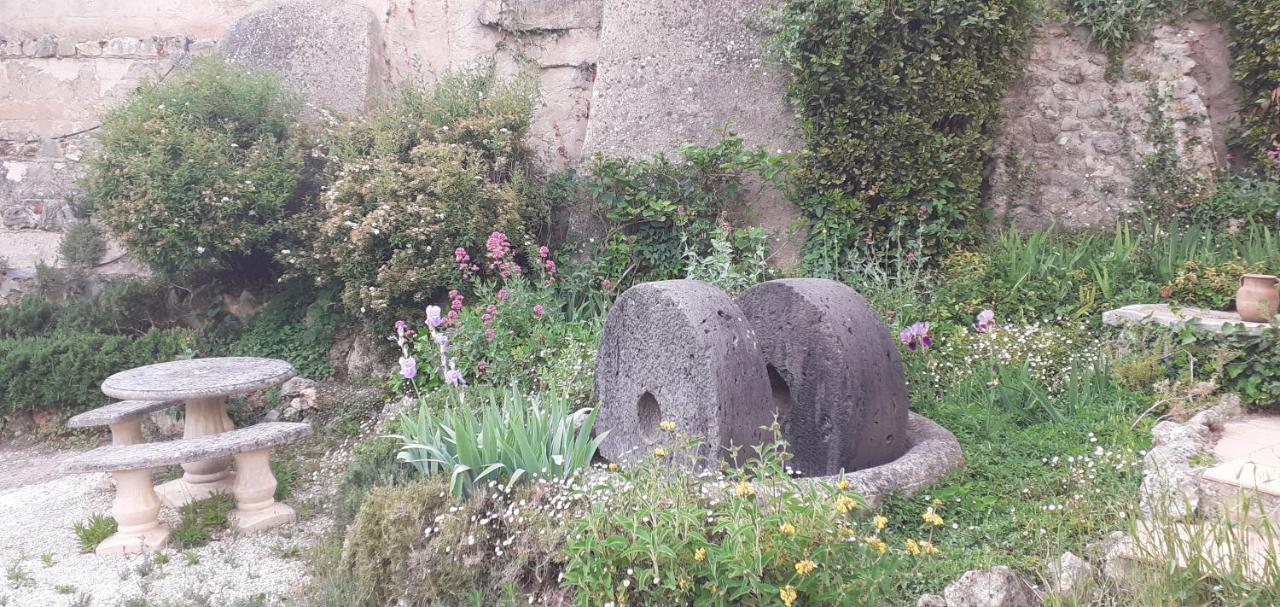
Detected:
[{"left": 93, "top": 470, "right": 169, "bottom": 556}]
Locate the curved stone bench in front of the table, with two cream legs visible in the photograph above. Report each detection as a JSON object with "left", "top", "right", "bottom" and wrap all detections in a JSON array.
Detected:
[{"left": 60, "top": 421, "right": 311, "bottom": 554}]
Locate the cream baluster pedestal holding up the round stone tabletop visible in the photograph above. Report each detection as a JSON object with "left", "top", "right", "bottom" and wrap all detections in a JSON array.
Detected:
[{"left": 156, "top": 397, "right": 236, "bottom": 508}]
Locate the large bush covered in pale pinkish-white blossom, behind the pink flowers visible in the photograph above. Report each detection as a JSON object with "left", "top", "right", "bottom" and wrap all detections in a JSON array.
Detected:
[{"left": 295, "top": 67, "right": 549, "bottom": 327}]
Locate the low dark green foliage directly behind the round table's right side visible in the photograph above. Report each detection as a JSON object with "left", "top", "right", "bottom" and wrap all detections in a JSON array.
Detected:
[{"left": 230, "top": 280, "right": 343, "bottom": 378}]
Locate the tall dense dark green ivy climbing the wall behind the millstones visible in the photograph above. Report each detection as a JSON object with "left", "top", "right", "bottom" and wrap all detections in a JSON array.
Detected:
[{"left": 780, "top": 0, "right": 1034, "bottom": 264}]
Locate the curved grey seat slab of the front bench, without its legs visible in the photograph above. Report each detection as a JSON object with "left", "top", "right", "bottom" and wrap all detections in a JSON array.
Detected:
[{"left": 60, "top": 421, "right": 311, "bottom": 474}]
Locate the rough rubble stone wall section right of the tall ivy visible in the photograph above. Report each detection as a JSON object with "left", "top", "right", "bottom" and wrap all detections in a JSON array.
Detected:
[{"left": 988, "top": 20, "right": 1235, "bottom": 228}]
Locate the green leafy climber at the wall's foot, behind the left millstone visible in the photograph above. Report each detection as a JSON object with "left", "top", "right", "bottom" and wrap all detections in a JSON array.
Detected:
[{"left": 581, "top": 134, "right": 787, "bottom": 284}]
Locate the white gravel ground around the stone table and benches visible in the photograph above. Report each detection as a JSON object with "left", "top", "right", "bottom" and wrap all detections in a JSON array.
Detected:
[{"left": 0, "top": 449, "right": 340, "bottom": 607}]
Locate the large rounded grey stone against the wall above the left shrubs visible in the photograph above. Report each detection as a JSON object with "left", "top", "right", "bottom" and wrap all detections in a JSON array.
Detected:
[{"left": 219, "top": 0, "right": 383, "bottom": 114}]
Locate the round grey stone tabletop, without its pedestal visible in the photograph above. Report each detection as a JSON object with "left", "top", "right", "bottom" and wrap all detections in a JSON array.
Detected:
[{"left": 102, "top": 356, "right": 297, "bottom": 401}]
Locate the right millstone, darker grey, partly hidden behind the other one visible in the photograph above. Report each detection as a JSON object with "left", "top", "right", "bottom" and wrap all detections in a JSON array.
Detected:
[{"left": 737, "top": 278, "right": 909, "bottom": 476}]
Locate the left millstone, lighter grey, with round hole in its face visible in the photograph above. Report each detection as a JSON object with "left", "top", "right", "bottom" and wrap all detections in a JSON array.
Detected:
[{"left": 595, "top": 280, "right": 773, "bottom": 461}]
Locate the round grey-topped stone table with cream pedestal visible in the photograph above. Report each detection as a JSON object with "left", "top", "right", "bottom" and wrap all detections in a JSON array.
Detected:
[{"left": 102, "top": 357, "right": 297, "bottom": 507}]
